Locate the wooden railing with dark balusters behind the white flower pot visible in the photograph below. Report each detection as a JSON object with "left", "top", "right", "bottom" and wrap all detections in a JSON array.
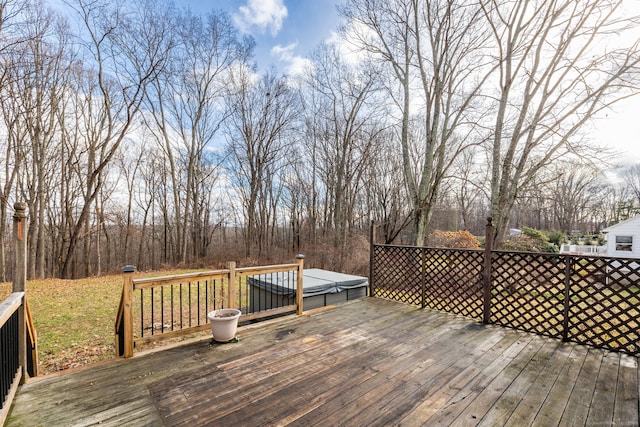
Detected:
[{"left": 115, "top": 255, "right": 304, "bottom": 357}]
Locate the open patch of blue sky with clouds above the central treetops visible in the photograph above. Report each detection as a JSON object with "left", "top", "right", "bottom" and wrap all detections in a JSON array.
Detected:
[{"left": 180, "top": 0, "right": 341, "bottom": 74}]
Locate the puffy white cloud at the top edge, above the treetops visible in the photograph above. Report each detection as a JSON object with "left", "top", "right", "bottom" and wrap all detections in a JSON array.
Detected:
[{"left": 233, "top": 0, "right": 288, "bottom": 37}]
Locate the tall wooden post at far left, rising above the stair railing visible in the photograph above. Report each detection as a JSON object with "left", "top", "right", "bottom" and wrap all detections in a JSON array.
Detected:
[{"left": 13, "top": 202, "right": 28, "bottom": 384}]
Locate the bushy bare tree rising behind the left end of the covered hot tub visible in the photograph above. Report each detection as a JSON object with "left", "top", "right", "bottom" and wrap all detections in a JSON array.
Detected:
[{"left": 227, "top": 68, "right": 297, "bottom": 257}]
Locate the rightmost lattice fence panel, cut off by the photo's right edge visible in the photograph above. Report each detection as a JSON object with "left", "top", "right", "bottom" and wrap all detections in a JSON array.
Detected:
[{"left": 568, "top": 257, "right": 640, "bottom": 355}]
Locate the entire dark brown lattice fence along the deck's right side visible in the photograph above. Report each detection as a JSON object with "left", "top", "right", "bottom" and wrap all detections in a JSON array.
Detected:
[{"left": 370, "top": 221, "right": 640, "bottom": 356}]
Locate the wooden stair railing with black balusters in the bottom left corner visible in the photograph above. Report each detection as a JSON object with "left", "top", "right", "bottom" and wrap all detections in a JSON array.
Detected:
[{"left": 0, "top": 292, "right": 38, "bottom": 425}]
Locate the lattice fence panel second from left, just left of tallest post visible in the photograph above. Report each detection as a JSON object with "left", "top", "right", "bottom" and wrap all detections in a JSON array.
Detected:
[{"left": 424, "top": 249, "right": 483, "bottom": 319}]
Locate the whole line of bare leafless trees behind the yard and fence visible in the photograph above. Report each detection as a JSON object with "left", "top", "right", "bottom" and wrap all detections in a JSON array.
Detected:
[{"left": 0, "top": 0, "right": 640, "bottom": 279}]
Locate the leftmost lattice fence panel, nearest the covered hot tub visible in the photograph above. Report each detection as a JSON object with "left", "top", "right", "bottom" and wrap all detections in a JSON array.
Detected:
[{"left": 373, "top": 245, "right": 421, "bottom": 305}]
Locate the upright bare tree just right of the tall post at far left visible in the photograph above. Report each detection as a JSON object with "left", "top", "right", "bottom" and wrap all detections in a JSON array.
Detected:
[{"left": 13, "top": 5, "right": 71, "bottom": 278}]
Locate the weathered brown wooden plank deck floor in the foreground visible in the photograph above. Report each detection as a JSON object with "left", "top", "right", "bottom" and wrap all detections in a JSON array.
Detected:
[{"left": 7, "top": 298, "right": 639, "bottom": 426}]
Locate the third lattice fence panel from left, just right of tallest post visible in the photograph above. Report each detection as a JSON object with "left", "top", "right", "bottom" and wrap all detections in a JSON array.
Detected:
[{"left": 491, "top": 252, "right": 565, "bottom": 338}]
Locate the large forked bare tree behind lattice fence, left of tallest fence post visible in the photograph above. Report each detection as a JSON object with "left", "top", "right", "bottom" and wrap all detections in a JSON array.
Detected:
[{"left": 343, "top": 0, "right": 488, "bottom": 245}]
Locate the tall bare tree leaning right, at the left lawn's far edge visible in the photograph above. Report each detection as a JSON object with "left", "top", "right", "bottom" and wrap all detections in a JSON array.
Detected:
[{"left": 60, "top": 0, "right": 170, "bottom": 278}]
